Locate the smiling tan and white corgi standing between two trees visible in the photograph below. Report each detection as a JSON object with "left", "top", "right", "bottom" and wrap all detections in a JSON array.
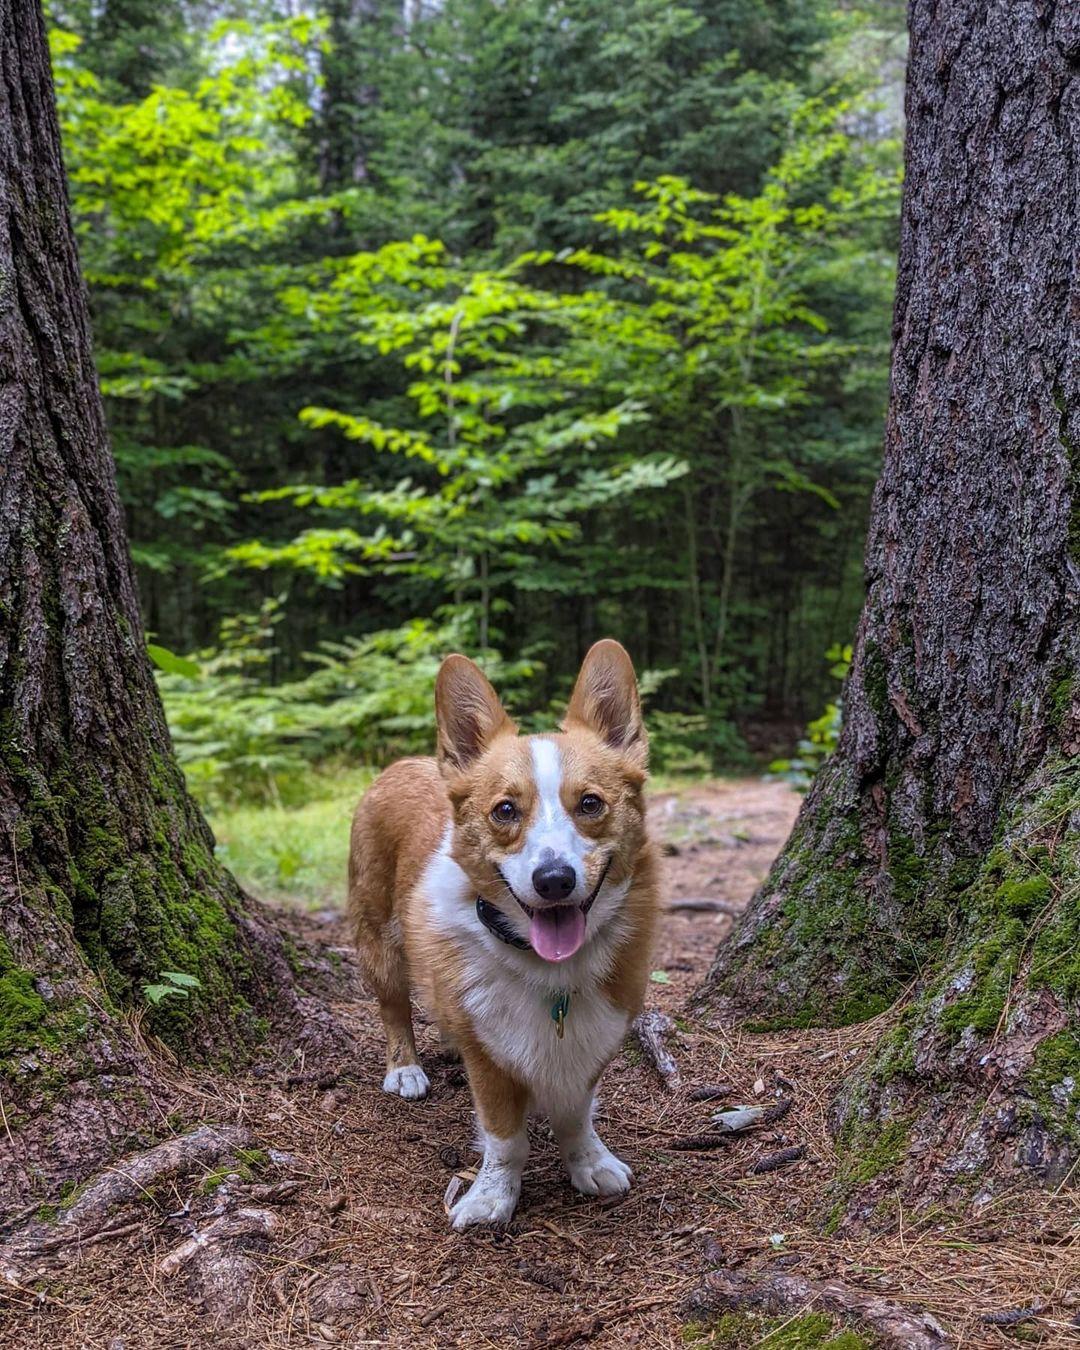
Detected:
[{"left": 348, "top": 640, "right": 659, "bottom": 1230}]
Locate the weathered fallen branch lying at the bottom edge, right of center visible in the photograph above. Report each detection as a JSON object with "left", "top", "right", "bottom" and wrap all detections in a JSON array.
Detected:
[{"left": 686, "top": 1270, "right": 953, "bottom": 1350}]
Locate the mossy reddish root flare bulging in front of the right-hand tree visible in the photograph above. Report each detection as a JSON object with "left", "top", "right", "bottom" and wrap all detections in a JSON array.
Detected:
[{"left": 833, "top": 759, "right": 1080, "bottom": 1223}]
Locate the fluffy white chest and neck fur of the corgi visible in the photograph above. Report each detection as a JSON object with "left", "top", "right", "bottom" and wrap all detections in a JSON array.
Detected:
[{"left": 421, "top": 832, "right": 629, "bottom": 1115}]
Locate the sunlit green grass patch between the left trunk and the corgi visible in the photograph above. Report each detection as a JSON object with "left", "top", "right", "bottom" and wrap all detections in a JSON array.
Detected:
[{"left": 211, "top": 768, "right": 377, "bottom": 910}]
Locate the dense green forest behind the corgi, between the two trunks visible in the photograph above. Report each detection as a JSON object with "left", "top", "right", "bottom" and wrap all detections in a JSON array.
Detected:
[{"left": 50, "top": 0, "right": 905, "bottom": 806}]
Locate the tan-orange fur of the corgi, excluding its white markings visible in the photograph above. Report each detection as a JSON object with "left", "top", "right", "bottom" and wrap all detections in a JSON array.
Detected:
[{"left": 348, "top": 643, "right": 659, "bottom": 1225}]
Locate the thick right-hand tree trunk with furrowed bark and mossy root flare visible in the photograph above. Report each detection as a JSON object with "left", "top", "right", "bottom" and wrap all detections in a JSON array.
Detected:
[{"left": 701, "top": 0, "right": 1080, "bottom": 1220}]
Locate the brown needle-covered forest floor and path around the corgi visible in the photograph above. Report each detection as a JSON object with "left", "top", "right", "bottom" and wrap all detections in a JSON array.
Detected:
[{"left": 0, "top": 780, "right": 1080, "bottom": 1350}]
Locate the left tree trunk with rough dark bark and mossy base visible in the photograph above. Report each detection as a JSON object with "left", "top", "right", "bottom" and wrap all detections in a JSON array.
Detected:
[{"left": 0, "top": 0, "right": 344, "bottom": 1220}]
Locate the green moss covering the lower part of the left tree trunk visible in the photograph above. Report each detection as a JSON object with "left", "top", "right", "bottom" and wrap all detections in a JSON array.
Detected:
[{"left": 0, "top": 702, "right": 274, "bottom": 1060}]
